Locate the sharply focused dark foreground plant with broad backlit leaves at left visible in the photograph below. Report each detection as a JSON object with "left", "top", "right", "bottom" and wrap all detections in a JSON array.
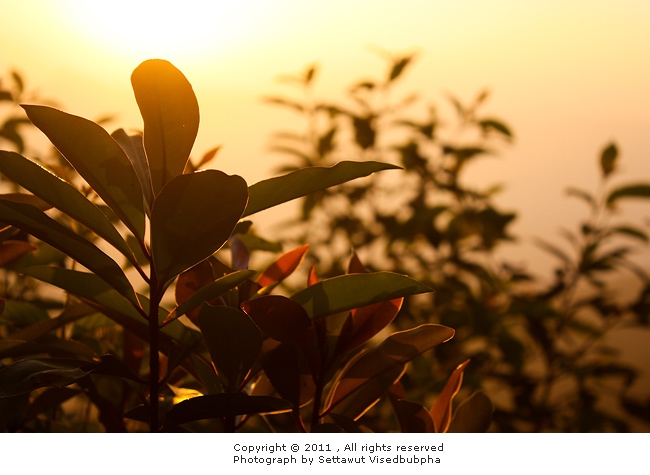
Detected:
[{"left": 0, "top": 60, "right": 492, "bottom": 432}]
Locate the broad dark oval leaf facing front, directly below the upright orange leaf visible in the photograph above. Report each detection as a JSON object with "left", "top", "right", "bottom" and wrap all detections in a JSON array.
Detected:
[{"left": 151, "top": 170, "right": 248, "bottom": 284}]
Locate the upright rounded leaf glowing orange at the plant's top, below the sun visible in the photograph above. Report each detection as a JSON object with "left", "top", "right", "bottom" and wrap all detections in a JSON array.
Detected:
[{"left": 131, "top": 59, "right": 199, "bottom": 196}]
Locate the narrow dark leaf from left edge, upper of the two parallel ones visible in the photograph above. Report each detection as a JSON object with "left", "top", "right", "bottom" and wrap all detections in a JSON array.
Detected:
[{"left": 0, "top": 151, "right": 137, "bottom": 265}]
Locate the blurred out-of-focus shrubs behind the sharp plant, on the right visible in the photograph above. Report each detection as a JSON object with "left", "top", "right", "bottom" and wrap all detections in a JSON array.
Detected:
[{"left": 267, "top": 55, "right": 650, "bottom": 431}]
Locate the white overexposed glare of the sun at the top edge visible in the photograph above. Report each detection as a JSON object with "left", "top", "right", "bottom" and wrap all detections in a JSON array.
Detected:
[{"left": 59, "top": 0, "right": 265, "bottom": 60}]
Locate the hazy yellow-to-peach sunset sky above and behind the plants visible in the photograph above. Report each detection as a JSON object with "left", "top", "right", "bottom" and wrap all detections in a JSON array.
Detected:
[{"left": 0, "top": 0, "right": 650, "bottom": 273}]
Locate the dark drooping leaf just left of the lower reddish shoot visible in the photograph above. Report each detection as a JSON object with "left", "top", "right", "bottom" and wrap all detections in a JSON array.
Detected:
[{"left": 198, "top": 303, "right": 262, "bottom": 393}]
